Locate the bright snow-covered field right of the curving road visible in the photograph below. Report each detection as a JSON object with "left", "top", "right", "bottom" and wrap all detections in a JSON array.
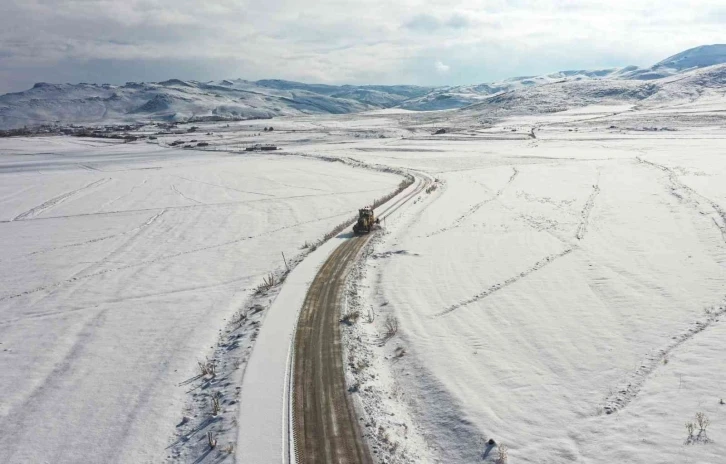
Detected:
[{"left": 320, "top": 109, "right": 726, "bottom": 464}]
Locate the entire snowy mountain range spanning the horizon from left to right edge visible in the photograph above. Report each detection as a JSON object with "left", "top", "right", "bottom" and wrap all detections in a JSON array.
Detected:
[{"left": 0, "top": 45, "right": 726, "bottom": 129}]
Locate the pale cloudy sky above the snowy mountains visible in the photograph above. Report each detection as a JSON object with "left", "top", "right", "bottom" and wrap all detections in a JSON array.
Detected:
[{"left": 0, "top": 0, "right": 726, "bottom": 93}]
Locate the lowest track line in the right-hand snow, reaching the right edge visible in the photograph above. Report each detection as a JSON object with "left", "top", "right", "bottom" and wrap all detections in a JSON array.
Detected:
[{"left": 601, "top": 298, "right": 726, "bottom": 414}]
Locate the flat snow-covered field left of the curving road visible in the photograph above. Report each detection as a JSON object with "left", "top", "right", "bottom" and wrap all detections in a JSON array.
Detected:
[{"left": 0, "top": 138, "right": 400, "bottom": 464}]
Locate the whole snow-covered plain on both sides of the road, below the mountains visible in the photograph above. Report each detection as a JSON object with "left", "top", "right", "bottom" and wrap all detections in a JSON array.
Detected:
[{"left": 0, "top": 91, "right": 726, "bottom": 464}]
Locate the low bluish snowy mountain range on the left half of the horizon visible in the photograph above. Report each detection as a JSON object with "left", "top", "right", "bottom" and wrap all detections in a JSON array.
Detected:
[{"left": 0, "top": 79, "right": 431, "bottom": 129}]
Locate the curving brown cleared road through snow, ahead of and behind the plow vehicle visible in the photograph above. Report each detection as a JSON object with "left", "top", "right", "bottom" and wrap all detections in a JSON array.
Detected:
[{"left": 291, "top": 177, "right": 431, "bottom": 464}]
